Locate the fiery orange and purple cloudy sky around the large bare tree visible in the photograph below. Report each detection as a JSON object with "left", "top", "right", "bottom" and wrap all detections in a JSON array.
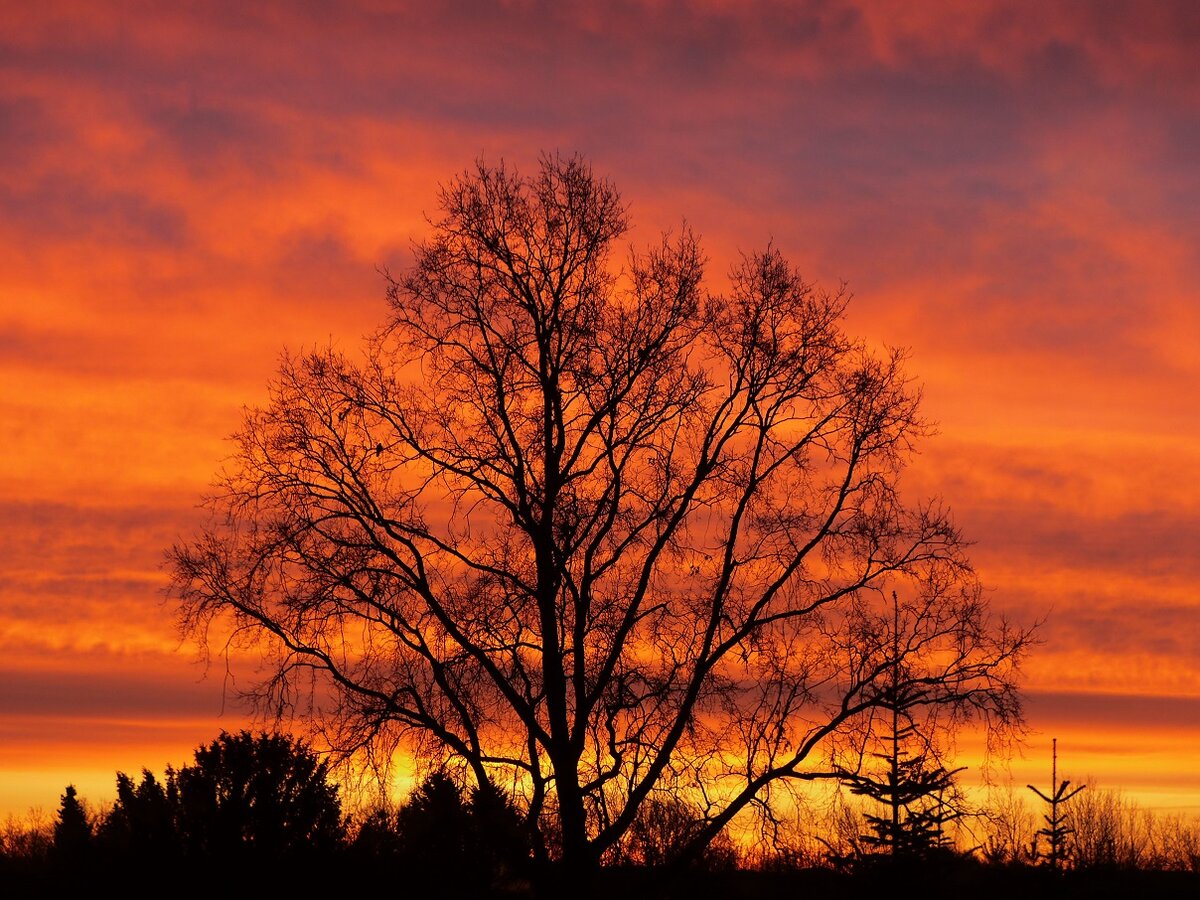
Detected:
[{"left": 0, "top": 0, "right": 1200, "bottom": 816}]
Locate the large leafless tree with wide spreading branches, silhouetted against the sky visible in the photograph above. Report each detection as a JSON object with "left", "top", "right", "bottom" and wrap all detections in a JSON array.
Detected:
[{"left": 170, "top": 156, "right": 1028, "bottom": 877}]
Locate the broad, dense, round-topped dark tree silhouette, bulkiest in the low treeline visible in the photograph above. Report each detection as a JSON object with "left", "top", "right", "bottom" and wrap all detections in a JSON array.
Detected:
[{"left": 168, "top": 731, "right": 344, "bottom": 859}]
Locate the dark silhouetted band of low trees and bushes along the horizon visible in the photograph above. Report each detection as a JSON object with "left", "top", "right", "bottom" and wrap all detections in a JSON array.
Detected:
[{"left": 0, "top": 732, "right": 1200, "bottom": 899}]
